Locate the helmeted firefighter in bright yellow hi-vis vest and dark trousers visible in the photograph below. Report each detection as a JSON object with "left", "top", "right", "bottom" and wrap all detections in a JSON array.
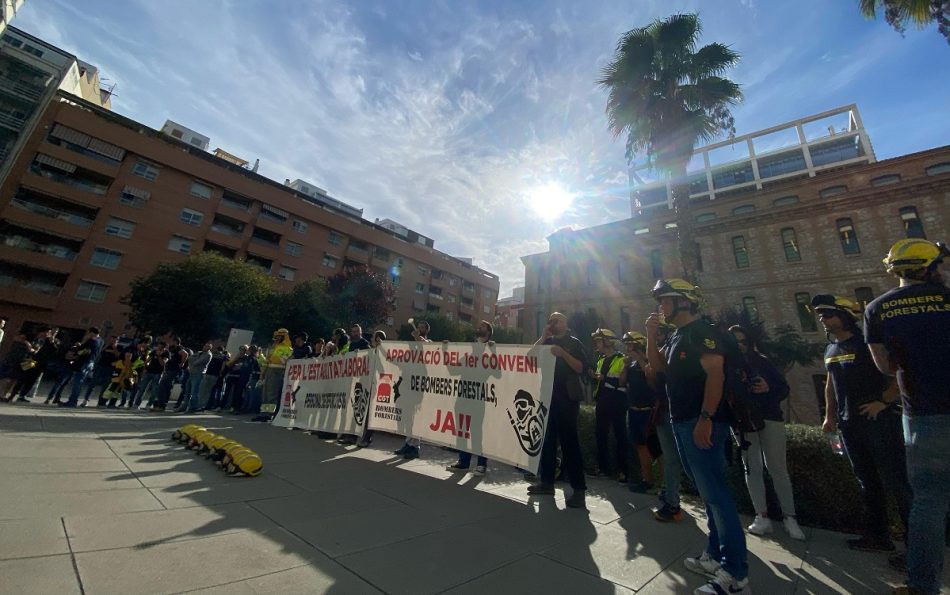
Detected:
[{"left": 591, "top": 328, "right": 627, "bottom": 483}]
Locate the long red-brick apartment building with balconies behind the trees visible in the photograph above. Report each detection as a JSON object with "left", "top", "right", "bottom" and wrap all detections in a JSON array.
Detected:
[{"left": 0, "top": 91, "right": 499, "bottom": 344}]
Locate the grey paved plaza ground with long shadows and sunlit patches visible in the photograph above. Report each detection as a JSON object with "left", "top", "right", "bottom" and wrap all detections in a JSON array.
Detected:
[{"left": 0, "top": 405, "right": 950, "bottom": 595}]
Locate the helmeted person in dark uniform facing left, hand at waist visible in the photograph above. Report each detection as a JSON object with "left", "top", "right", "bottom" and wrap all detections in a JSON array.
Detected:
[{"left": 811, "top": 294, "right": 910, "bottom": 552}]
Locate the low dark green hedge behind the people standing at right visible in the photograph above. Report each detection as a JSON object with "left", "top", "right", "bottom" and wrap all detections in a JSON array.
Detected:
[{"left": 578, "top": 405, "right": 950, "bottom": 544}]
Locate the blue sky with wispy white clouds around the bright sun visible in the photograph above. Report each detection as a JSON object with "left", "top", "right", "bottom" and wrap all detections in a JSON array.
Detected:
[{"left": 13, "top": 0, "right": 950, "bottom": 296}]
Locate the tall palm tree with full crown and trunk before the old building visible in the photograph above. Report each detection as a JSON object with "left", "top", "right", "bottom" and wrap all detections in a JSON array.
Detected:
[{"left": 597, "top": 14, "right": 742, "bottom": 282}]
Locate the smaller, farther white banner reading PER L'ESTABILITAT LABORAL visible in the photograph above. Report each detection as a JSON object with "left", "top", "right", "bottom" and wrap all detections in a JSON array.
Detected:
[{"left": 273, "top": 351, "right": 376, "bottom": 436}]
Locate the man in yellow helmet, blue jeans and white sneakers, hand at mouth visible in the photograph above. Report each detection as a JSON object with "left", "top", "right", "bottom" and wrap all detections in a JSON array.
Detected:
[{"left": 646, "top": 279, "right": 749, "bottom": 594}]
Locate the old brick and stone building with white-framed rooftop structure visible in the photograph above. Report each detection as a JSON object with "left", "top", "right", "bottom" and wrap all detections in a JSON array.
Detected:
[{"left": 521, "top": 106, "right": 950, "bottom": 423}]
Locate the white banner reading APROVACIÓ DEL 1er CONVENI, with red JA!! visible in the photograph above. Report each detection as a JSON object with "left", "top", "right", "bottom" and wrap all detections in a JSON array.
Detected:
[{"left": 369, "top": 341, "right": 555, "bottom": 472}]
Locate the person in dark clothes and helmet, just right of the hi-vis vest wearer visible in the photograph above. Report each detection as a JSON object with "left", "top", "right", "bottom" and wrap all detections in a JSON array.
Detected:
[{"left": 620, "top": 331, "right": 656, "bottom": 493}]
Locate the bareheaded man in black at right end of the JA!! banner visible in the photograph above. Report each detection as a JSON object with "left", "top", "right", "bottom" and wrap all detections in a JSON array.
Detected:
[{"left": 528, "top": 312, "right": 587, "bottom": 508}]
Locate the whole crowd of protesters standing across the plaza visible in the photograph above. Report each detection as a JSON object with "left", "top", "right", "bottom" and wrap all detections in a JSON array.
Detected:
[{"left": 0, "top": 239, "right": 950, "bottom": 595}]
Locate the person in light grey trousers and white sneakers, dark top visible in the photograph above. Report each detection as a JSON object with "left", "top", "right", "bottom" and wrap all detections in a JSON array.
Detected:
[{"left": 729, "top": 324, "right": 805, "bottom": 540}]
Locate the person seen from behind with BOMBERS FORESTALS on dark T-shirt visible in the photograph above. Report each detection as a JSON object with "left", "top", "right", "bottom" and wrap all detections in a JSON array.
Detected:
[{"left": 864, "top": 238, "right": 950, "bottom": 593}]
